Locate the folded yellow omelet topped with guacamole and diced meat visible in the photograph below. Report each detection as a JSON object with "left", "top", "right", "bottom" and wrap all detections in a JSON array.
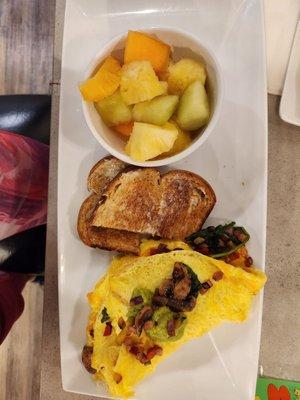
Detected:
[{"left": 85, "top": 250, "right": 266, "bottom": 397}]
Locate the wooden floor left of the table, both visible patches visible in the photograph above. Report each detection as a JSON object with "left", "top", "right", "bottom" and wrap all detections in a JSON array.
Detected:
[{"left": 0, "top": 0, "right": 55, "bottom": 400}]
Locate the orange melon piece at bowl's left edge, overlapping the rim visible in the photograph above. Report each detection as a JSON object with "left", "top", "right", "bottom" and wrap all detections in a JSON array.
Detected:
[{"left": 79, "top": 56, "right": 121, "bottom": 101}]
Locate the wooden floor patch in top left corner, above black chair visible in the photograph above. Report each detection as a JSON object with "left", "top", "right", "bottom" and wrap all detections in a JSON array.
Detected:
[{"left": 0, "top": 0, "right": 55, "bottom": 94}]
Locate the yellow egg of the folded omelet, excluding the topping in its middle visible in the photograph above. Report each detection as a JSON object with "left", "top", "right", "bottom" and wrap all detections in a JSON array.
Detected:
[{"left": 85, "top": 250, "right": 266, "bottom": 397}]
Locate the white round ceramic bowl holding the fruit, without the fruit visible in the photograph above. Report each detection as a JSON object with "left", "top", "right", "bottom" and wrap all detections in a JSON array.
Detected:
[{"left": 82, "top": 28, "right": 223, "bottom": 167}]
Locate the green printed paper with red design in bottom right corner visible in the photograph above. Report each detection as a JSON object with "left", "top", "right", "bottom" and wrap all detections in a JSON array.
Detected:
[{"left": 255, "top": 377, "right": 300, "bottom": 400}]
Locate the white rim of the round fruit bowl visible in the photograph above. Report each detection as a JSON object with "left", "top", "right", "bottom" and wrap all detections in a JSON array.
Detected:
[{"left": 81, "top": 26, "right": 224, "bottom": 167}]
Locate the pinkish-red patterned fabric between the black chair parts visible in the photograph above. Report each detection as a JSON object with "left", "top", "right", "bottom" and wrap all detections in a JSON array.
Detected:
[{"left": 0, "top": 130, "right": 49, "bottom": 240}]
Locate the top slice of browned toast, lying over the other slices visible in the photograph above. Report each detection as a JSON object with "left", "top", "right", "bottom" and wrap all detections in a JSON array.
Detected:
[{"left": 92, "top": 168, "right": 216, "bottom": 239}]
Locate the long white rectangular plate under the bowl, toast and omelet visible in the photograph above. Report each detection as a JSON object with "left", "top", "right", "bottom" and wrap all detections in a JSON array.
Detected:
[{"left": 58, "top": 0, "right": 267, "bottom": 400}]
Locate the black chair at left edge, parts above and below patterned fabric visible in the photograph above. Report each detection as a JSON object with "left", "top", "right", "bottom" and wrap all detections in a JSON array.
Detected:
[{"left": 0, "top": 95, "right": 51, "bottom": 274}]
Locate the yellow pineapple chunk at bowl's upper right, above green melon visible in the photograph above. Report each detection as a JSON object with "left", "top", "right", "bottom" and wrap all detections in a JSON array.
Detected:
[{"left": 168, "top": 58, "right": 206, "bottom": 95}]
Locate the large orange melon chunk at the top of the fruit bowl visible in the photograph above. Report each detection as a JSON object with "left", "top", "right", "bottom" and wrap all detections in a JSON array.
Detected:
[{"left": 124, "top": 31, "right": 171, "bottom": 73}]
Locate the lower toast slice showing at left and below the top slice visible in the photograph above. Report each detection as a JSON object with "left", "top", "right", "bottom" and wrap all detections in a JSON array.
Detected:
[{"left": 77, "top": 194, "right": 140, "bottom": 254}]
